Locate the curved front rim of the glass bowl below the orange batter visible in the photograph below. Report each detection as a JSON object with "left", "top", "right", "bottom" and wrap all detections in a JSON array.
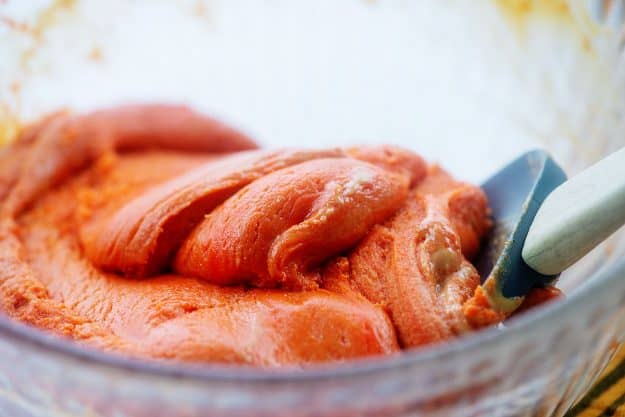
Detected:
[{"left": 0, "top": 255, "right": 625, "bottom": 384}]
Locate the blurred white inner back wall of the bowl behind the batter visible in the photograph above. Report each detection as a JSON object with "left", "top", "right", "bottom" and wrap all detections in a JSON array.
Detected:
[{"left": 0, "top": 0, "right": 625, "bottom": 181}]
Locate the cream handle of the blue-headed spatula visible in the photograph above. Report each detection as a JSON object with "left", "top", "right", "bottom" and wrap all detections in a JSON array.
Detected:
[{"left": 523, "top": 148, "right": 625, "bottom": 275}]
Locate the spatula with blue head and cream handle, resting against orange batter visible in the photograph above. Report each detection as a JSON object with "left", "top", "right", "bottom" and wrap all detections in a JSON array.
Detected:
[{"left": 476, "top": 148, "right": 625, "bottom": 315}]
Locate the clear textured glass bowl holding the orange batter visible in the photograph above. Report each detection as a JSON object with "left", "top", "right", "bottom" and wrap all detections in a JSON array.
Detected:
[{"left": 0, "top": 0, "right": 625, "bottom": 417}]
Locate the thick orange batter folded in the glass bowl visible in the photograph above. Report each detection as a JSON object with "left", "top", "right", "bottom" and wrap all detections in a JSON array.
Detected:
[{"left": 0, "top": 106, "right": 497, "bottom": 366}]
